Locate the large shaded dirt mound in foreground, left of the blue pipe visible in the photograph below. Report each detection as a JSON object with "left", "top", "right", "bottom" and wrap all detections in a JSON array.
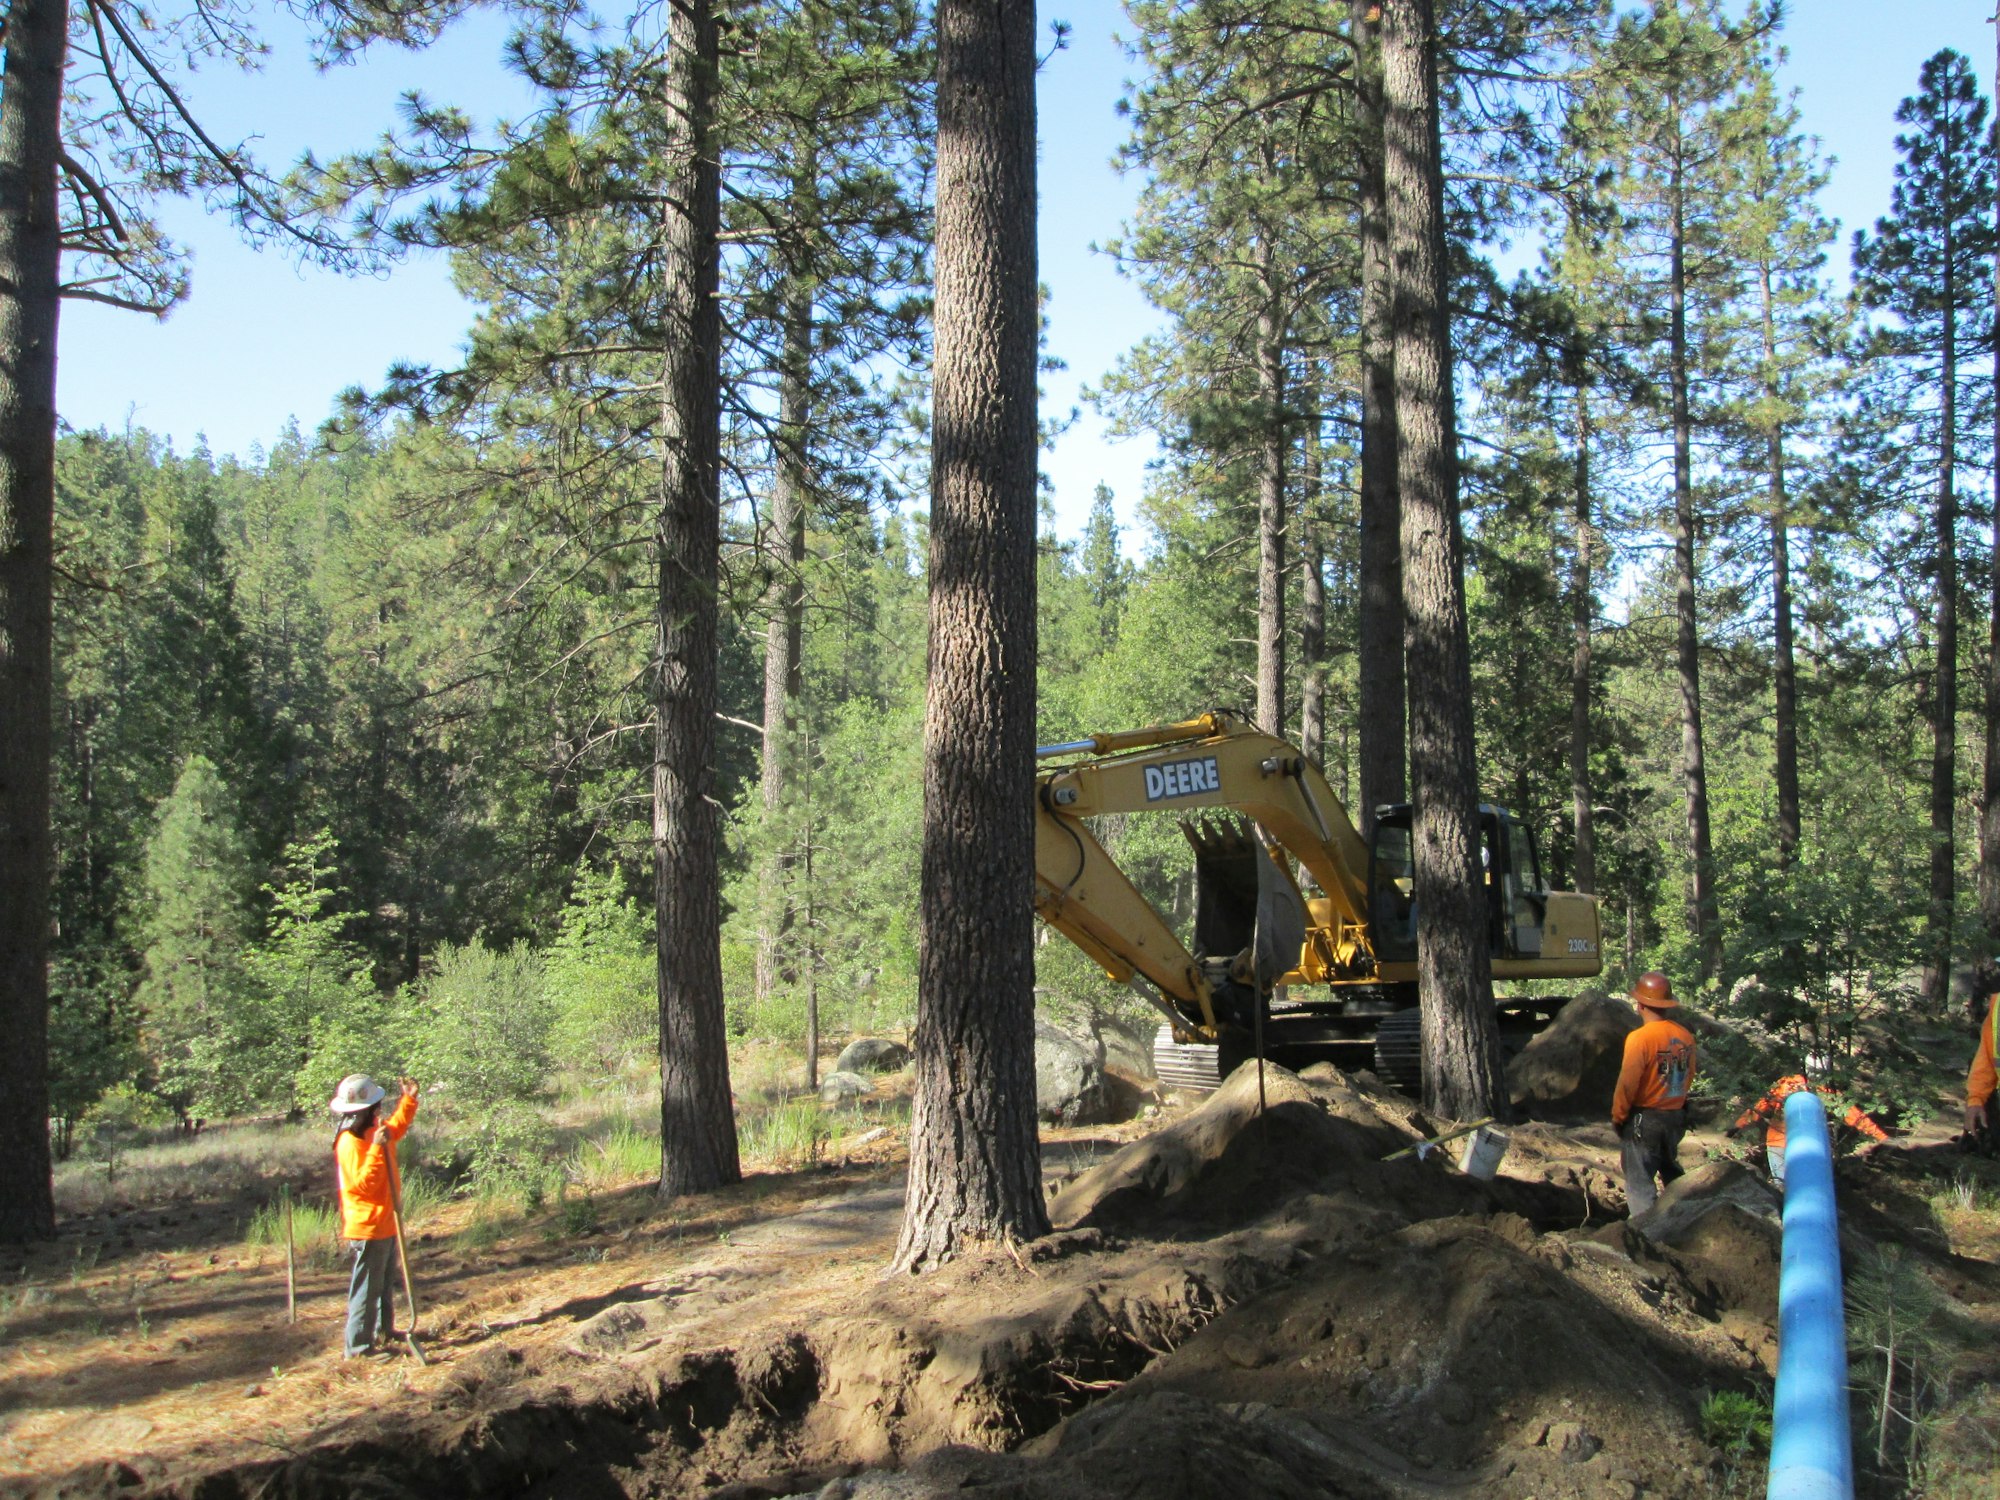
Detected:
[{"left": 1096, "top": 1216, "right": 1706, "bottom": 1494}]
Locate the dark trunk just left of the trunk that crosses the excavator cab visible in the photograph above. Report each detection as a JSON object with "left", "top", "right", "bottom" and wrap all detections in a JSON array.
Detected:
[{"left": 1350, "top": 0, "right": 1408, "bottom": 838}]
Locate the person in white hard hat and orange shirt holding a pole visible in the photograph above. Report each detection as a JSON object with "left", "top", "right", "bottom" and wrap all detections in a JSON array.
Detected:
[{"left": 330, "top": 1074, "right": 416, "bottom": 1360}]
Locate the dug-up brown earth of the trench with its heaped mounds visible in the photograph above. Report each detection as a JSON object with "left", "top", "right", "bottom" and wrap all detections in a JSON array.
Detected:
[{"left": 27, "top": 1070, "right": 1776, "bottom": 1500}]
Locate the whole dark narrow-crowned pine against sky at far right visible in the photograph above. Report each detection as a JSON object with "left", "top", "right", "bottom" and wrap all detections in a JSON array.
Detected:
[{"left": 1854, "top": 48, "right": 1994, "bottom": 1000}]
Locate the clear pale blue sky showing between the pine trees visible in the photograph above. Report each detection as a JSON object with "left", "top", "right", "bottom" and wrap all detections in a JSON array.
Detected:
[{"left": 47, "top": 0, "right": 1994, "bottom": 532}]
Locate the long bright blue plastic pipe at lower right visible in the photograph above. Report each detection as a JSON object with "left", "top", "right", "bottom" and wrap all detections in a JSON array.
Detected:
[{"left": 1764, "top": 1090, "right": 1854, "bottom": 1500}]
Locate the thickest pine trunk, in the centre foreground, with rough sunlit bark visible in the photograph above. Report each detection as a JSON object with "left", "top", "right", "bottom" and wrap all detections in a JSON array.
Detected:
[{"left": 896, "top": 0, "right": 1048, "bottom": 1270}]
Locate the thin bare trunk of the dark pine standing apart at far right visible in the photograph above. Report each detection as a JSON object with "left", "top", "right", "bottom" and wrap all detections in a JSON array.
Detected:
[{"left": 1922, "top": 235, "right": 1958, "bottom": 1002}]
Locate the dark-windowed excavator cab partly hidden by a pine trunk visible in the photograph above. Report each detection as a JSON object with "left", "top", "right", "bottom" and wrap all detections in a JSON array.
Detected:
[{"left": 1368, "top": 802, "right": 1548, "bottom": 964}]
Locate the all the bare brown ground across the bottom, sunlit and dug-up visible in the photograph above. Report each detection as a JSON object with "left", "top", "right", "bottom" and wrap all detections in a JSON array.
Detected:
[{"left": 0, "top": 1068, "right": 2000, "bottom": 1500}]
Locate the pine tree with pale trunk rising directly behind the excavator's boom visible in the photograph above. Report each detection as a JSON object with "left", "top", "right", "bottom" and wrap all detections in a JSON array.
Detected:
[{"left": 1106, "top": 4, "right": 1352, "bottom": 734}]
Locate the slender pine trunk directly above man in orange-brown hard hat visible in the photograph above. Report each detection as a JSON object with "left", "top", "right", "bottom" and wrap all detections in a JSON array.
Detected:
[{"left": 1668, "top": 142, "right": 1722, "bottom": 980}]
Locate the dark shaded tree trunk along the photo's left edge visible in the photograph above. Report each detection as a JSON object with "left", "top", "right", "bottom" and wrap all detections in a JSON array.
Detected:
[{"left": 0, "top": 0, "right": 68, "bottom": 1242}]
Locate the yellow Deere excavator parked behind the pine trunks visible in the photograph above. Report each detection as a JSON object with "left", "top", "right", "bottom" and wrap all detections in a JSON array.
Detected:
[{"left": 1034, "top": 710, "right": 1602, "bottom": 1092}]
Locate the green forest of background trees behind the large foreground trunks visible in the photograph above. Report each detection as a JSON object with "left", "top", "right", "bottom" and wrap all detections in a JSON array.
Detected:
[{"left": 15, "top": 0, "right": 2000, "bottom": 1160}]
